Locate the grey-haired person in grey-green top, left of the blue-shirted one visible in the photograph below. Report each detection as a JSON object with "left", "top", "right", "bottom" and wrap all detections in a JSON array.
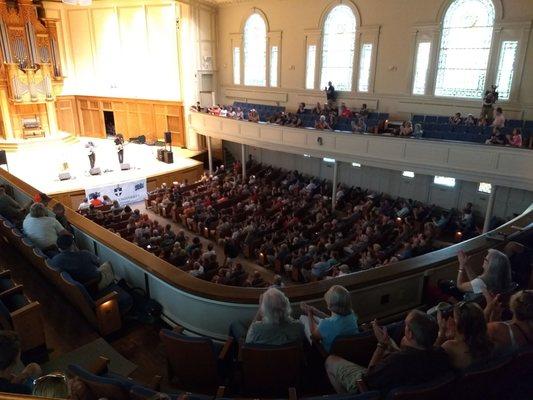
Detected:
[{"left": 230, "top": 288, "right": 305, "bottom": 346}]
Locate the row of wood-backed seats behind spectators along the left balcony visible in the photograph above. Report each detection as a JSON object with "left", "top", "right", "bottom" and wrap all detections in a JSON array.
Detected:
[{"left": 0, "top": 214, "right": 133, "bottom": 336}]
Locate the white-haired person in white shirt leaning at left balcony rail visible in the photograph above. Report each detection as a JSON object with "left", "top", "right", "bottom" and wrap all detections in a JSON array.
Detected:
[{"left": 22, "top": 203, "right": 71, "bottom": 257}]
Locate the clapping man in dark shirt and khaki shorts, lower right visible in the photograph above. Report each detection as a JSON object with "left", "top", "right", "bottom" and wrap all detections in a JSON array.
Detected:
[{"left": 326, "top": 310, "right": 451, "bottom": 395}]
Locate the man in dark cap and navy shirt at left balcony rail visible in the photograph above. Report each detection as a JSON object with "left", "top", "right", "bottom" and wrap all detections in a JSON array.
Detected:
[{"left": 48, "top": 235, "right": 101, "bottom": 285}]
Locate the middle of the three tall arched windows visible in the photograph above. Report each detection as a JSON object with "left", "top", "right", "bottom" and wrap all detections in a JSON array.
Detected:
[{"left": 320, "top": 4, "right": 356, "bottom": 92}]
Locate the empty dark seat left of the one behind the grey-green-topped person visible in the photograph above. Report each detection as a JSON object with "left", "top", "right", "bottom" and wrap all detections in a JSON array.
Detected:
[{"left": 159, "top": 327, "right": 233, "bottom": 393}]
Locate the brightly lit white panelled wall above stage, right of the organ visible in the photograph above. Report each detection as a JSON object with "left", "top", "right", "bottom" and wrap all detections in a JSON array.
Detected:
[{"left": 44, "top": 0, "right": 181, "bottom": 100}]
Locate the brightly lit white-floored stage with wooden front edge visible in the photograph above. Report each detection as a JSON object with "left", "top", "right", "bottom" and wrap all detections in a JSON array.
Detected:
[{"left": 1, "top": 137, "right": 203, "bottom": 208}]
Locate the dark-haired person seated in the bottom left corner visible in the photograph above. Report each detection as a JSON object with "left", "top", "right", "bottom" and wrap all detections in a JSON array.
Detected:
[{"left": 0, "top": 331, "right": 42, "bottom": 394}]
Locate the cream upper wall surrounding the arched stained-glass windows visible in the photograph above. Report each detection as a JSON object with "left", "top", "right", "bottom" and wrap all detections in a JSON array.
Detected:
[{"left": 217, "top": 0, "right": 533, "bottom": 119}]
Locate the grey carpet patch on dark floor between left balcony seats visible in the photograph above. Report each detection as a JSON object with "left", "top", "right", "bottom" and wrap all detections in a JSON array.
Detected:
[{"left": 42, "top": 338, "right": 137, "bottom": 376}]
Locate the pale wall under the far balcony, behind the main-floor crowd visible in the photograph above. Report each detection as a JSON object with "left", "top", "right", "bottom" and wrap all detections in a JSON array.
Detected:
[{"left": 224, "top": 141, "right": 533, "bottom": 222}]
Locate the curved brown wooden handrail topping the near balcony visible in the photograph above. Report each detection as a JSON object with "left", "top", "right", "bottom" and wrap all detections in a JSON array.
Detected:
[{"left": 0, "top": 168, "right": 533, "bottom": 304}]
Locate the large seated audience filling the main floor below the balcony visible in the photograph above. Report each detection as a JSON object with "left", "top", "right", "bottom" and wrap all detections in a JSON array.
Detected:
[{"left": 143, "top": 160, "right": 446, "bottom": 282}]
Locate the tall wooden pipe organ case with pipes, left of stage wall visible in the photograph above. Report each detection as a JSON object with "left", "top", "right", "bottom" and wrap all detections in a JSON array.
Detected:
[{"left": 0, "top": 0, "right": 62, "bottom": 140}]
